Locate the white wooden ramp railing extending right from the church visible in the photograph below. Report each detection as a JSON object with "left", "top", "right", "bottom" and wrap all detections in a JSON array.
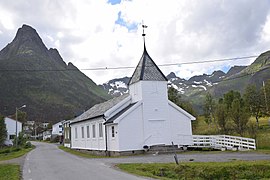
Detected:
[{"left": 190, "top": 135, "right": 256, "bottom": 151}]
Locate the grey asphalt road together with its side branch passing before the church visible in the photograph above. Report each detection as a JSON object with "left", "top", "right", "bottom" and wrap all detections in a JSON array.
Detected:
[{"left": 23, "top": 142, "right": 270, "bottom": 180}]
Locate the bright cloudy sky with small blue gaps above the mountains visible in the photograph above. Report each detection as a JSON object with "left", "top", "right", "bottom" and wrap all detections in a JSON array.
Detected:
[{"left": 0, "top": 0, "right": 270, "bottom": 84}]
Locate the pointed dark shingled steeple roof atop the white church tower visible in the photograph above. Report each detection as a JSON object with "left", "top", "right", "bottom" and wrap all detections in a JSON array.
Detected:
[{"left": 128, "top": 45, "right": 168, "bottom": 85}]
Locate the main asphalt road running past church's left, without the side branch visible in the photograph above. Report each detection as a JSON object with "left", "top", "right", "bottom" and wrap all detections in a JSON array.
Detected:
[{"left": 23, "top": 142, "right": 147, "bottom": 180}]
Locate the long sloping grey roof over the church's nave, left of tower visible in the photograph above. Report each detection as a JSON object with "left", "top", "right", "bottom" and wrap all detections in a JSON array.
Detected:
[{"left": 71, "top": 94, "right": 129, "bottom": 123}]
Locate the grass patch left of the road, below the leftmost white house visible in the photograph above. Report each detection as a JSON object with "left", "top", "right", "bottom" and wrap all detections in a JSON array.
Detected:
[{"left": 0, "top": 145, "right": 34, "bottom": 162}]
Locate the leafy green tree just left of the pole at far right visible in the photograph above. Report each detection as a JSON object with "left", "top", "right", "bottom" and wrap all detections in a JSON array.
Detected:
[{"left": 244, "top": 85, "right": 264, "bottom": 127}]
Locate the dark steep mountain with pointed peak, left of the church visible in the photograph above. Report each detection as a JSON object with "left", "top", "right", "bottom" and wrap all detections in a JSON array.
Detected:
[{"left": 0, "top": 25, "right": 110, "bottom": 122}]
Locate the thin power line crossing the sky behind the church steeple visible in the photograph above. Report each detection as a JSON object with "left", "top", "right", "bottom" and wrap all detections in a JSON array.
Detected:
[{"left": 0, "top": 55, "right": 262, "bottom": 72}]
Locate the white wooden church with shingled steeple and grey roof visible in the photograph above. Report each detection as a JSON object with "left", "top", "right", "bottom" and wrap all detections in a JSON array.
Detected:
[{"left": 70, "top": 40, "right": 195, "bottom": 154}]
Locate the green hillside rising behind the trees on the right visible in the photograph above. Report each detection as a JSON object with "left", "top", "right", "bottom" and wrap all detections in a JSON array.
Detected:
[{"left": 187, "top": 51, "right": 270, "bottom": 114}]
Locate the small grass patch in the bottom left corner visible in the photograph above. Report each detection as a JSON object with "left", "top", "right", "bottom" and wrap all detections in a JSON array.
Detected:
[{"left": 0, "top": 164, "right": 20, "bottom": 180}]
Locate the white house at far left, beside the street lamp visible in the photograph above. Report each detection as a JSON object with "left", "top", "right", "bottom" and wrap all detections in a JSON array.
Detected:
[{"left": 5, "top": 117, "right": 22, "bottom": 143}]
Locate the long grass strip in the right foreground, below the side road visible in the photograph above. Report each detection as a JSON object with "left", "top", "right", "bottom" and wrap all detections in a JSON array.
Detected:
[{"left": 116, "top": 161, "right": 270, "bottom": 179}]
